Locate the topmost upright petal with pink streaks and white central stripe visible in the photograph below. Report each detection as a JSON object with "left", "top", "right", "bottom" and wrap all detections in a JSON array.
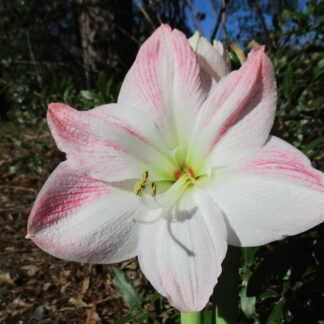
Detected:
[{"left": 118, "top": 25, "right": 207, "bottom": 148}]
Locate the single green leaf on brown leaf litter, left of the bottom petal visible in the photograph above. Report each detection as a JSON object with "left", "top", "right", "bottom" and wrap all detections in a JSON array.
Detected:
[{"left": 112, "top": 267, "right": 143, "bottom": 310}]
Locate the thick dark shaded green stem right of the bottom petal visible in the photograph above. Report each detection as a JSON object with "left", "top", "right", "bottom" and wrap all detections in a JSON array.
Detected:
[{"left": 212, "top": 246, "right": 241, "bottom": 324}]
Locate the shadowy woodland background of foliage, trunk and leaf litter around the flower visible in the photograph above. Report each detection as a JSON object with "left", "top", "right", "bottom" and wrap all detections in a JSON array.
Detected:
[{"left": 0, "top": 0, "right": 324, "bottom": 324}]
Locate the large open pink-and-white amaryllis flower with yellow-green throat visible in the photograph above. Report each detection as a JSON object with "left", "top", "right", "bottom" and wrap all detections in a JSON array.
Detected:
[{"left": 28, "top": 25, "right": 324, "bottom": 312}]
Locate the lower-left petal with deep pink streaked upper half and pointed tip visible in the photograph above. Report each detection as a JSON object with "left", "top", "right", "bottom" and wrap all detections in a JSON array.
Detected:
[{"left": 27, "top": 162, "right": 144, "bottom": 263}]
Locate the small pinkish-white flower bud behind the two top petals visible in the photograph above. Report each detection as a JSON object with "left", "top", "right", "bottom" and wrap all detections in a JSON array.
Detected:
[{"left": 189, "top": 32, "right": 230, "bottom": 85}]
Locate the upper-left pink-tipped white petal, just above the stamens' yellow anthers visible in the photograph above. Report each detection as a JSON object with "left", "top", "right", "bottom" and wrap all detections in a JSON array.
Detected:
[{"left": 47, "top": 104, "right": 174, "bottom": 181}]
